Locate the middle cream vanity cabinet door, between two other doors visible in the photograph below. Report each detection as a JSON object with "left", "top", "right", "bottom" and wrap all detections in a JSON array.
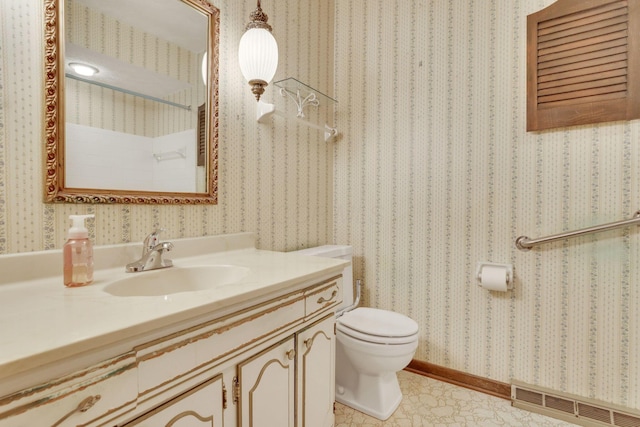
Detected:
[{"left": 238, "top": 337, "right": 296, "bottom": 427}]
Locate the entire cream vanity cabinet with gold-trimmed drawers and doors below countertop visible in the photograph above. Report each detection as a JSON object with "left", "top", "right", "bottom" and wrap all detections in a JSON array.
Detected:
[{"left": 0, "top": 241, "right": 342, "bottom": 427}]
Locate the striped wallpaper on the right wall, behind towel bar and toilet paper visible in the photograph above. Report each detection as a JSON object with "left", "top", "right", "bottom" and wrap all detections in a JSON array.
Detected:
[{"left": 334, "top": 0, "right": 640, "bottom": 408}]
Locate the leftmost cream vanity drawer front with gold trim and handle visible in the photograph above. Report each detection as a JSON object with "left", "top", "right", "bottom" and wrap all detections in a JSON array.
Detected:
[{"left": 0, "top": 353, "right": 138, "bottom": 427}]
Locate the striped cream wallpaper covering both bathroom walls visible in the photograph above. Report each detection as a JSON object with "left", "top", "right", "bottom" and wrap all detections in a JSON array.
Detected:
[{"left": 0, "top": 0, "right": 640, "bottom": 416}]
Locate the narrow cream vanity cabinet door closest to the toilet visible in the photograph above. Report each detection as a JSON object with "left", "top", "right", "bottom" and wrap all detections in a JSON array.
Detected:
[{"left": 297, "top": 314, "right": 336, "bottom": 427}]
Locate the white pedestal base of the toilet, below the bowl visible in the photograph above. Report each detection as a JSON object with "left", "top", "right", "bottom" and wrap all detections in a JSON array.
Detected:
[{"left": 336, "top": 372, "right": 402, "bottom": 421}]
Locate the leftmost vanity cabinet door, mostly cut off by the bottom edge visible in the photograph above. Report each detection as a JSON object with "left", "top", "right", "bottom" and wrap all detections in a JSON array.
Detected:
[{"left": 125, "top": 375, "right": 224, "bottom": 427}]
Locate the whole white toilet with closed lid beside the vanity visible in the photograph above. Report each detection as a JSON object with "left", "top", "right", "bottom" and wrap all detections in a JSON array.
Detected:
[{"left": 297, "top": 245, "right": 418, "bottom": 420}]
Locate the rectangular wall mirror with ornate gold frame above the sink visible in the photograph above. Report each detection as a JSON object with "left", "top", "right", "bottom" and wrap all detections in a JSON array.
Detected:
[{"left": 44, "top": 0, "right": 220, "bottom": 204}]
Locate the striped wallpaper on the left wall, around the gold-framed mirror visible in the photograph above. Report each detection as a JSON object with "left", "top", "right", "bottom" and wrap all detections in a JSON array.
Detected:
[{"left": 0, "top": 0, "right": 334, "bottom": 254}]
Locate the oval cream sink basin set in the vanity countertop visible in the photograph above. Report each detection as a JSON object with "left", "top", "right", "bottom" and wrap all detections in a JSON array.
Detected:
[{"left": 104, "top": 265, "right": 249, "bottom": 297}]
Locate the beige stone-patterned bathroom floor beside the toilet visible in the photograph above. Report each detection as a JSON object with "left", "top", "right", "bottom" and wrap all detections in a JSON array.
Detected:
[{"left": 335, "top": 371, "right": 574, "bottom": 427}]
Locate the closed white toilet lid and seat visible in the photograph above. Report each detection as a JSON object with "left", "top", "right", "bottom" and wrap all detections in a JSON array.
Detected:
[{"left": 337, "top": 307, "right": 418, "bottom": 342}]
